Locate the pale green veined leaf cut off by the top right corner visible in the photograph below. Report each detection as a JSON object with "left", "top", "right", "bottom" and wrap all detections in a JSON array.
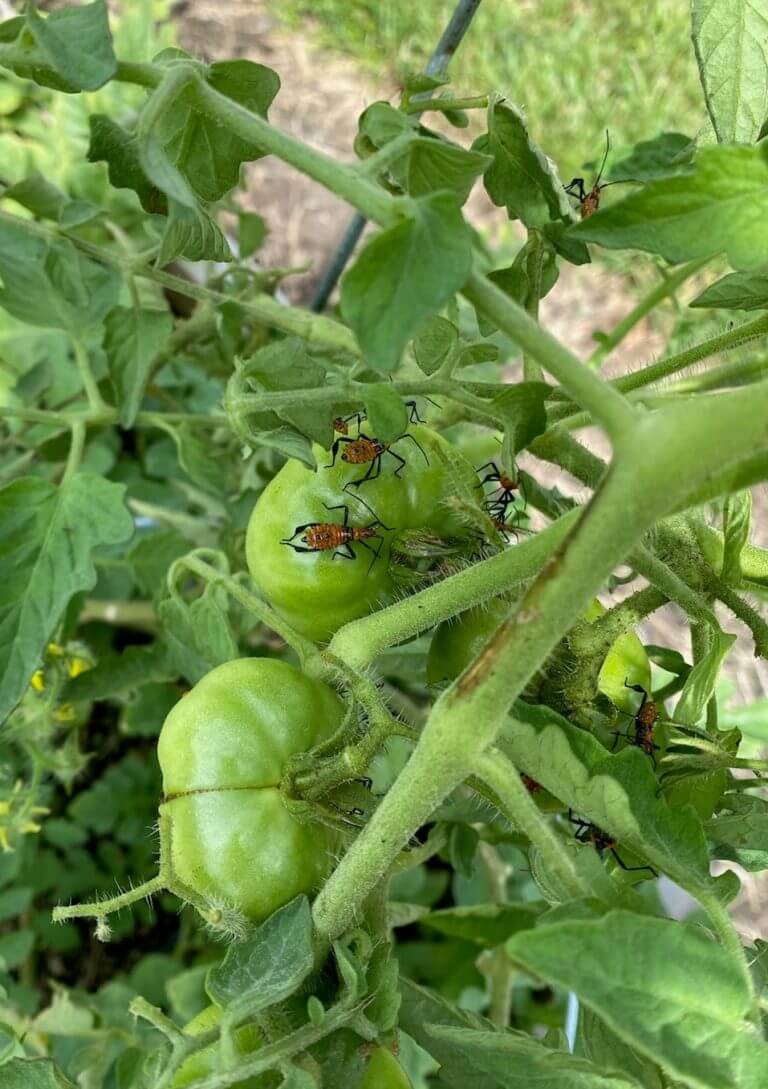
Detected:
[{"left": 691, "top": 0, "right": 768, "bottom": 144}]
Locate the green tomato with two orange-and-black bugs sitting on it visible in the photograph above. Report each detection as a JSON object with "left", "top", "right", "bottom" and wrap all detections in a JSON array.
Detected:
[{"left": 245, "top": 426, "right": 478, "bottom": 640}]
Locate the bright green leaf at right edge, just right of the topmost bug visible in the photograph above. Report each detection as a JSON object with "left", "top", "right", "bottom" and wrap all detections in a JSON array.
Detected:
[{"left": 570, "top": 145, "right": 768, "bottom": 269}]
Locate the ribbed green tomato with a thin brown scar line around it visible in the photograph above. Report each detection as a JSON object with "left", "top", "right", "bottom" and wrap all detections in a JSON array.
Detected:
[{"left": 158, "top": 658, "right": 344, "bottom": 921}]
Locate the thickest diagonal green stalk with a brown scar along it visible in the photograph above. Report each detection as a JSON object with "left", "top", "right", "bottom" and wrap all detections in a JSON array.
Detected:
[{"left": 314, "top": 383, "right": 768, "bottom": 937}]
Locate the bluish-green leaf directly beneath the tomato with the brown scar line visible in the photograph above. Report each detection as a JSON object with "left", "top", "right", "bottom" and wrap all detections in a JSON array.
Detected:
[{"left": 206, "top": 896, "right": 314, "bottom": 1019}]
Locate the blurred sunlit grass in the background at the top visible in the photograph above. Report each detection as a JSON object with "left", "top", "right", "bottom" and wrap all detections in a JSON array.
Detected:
[{"left": 276, "top": 0, "right": 706, "bottom": 176}]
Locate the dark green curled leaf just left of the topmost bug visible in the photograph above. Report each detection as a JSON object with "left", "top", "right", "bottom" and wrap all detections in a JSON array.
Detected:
[{"left": 473, "top": 99, "right": 575, "bottom": 227}]
